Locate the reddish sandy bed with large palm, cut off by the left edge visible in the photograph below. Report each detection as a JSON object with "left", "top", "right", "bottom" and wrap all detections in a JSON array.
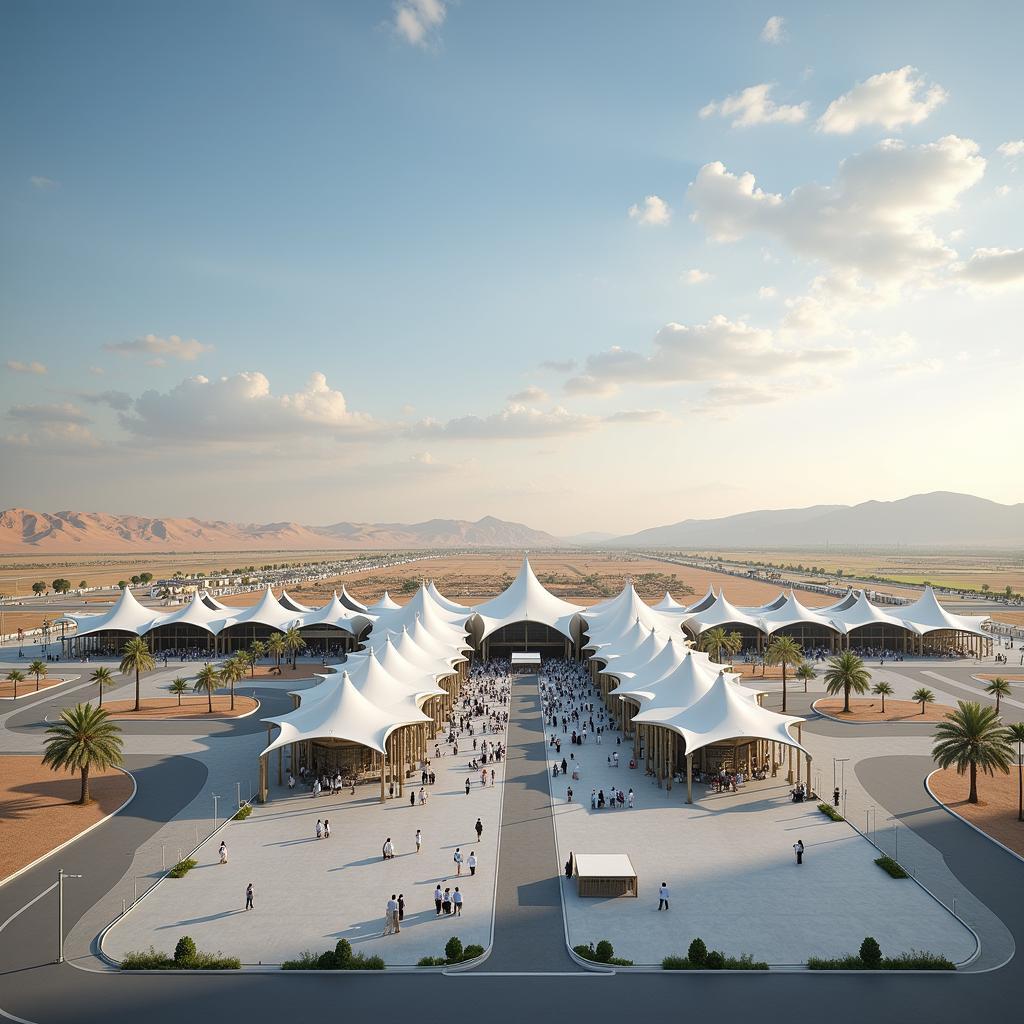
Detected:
[{"left": 0, "top": 755, "right": 132, "bottom": 879}]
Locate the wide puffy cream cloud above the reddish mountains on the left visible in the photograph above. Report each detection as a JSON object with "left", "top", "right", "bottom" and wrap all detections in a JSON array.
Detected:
[{"left": 121, "top": 371, "right": 380, "bottom": 443}]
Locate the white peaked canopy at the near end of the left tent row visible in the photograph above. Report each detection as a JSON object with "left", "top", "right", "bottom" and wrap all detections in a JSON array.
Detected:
[{"left": 262, "top": 672, "right": 429, "bottom": 754}]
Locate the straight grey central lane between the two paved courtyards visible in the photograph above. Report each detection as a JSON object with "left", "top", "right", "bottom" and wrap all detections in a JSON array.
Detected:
[{"left": 479, "top": 675, "right": 580, "bottom": 973}]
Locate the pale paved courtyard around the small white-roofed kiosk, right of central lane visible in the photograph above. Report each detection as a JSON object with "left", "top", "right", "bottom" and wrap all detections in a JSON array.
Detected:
[{"left": 548, "top": 679, "right": 975, "bottom": 965}]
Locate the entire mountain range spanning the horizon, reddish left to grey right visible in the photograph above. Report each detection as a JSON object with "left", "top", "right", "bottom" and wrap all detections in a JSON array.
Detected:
[{"left": 0, "top": 490, "right": 1024, "bottom": 555}]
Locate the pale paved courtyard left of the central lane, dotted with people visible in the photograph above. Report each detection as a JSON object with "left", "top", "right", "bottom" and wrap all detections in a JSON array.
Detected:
[{"left": 103, "top": 720, "right": 505, "bottom": 966}]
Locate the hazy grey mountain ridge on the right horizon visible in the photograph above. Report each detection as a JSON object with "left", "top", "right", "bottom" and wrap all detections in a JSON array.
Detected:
[{"left": 607, "top": 490, "right": 1024, "bottom": 550}]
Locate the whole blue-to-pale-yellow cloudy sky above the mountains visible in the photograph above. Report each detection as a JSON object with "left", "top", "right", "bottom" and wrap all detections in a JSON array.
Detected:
[{"left": 0, "top": 0, "right": 1024, "bottom": 536}]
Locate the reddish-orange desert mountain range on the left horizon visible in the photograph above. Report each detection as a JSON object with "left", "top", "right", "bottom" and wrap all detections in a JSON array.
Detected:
[{"left": 0, "top": 509, "right": 564, "bottom": 555}]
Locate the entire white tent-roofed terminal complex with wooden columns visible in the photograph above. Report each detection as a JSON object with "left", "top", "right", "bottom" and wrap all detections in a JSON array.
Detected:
[{"left": 59, "top": 559, "right": 990, "bottom": 802}]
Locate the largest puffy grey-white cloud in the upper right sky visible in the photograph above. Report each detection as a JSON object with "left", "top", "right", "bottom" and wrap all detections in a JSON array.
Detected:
[{"left": 687, "top": 135, "right": 985, "bottom": 283}]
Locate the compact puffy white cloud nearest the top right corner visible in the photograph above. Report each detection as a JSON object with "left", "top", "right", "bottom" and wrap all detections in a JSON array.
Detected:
[{"left": 817, "top": 65, "right": 947, "bottom": 135}]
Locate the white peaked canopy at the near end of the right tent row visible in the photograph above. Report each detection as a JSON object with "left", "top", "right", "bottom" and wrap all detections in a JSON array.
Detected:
[{"left": 633, "top": 670, "right": 807, "bottom": 754}]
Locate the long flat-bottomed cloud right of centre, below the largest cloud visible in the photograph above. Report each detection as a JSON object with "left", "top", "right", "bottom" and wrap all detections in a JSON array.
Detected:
[{"left": 573, "top": 315, "right": 854, "bottom": 386}]
